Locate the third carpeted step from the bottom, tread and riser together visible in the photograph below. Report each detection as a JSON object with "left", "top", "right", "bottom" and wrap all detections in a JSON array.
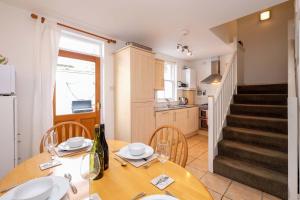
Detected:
[{"left": 223, "top": 126, "right": 288, "bottom": 152}]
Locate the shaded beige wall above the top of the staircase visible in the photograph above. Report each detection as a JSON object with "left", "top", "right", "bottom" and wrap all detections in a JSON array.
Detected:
[{"left": 238, "top": 1, "right": 293, "bottom": 84}]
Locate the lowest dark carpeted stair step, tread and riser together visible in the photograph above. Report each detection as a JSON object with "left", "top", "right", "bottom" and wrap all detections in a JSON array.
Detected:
[{"left": 214, "top": 156, "right": 288, "bottom": 199}]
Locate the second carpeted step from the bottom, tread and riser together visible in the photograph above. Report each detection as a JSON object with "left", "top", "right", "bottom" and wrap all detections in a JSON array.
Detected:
[{"left": 218, "top": 139, "right": 288, "bottom": 173}]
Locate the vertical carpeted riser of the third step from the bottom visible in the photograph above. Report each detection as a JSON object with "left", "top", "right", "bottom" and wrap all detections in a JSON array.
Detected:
[{"left": 223, "top": 129, "right": 288, "bottom": 153}]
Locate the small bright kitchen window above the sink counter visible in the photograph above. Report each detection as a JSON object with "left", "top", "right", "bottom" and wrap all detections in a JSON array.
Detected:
[{"left": 156, "top": 62, "right": 177, "bottom": 100}]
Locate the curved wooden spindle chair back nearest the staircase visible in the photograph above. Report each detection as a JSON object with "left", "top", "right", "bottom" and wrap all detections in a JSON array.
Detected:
[{"left": 149, "top": 126, "right": 188, "bottom": 167}]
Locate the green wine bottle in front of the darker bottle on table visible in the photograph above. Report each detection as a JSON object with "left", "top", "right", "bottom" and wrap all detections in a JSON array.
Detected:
[{"left": 91, "top": 124, "right": 104, "bottom": 180}]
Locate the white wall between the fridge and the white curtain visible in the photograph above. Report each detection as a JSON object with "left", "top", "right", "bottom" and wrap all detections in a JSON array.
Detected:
[{"left": 0, "top": 2, "right": 34, "bottom": 161}]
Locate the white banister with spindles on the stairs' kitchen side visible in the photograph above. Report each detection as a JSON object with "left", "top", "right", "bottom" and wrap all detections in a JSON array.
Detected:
[{"left": 208, "top": 52, "right": 237, "bottom": 172}]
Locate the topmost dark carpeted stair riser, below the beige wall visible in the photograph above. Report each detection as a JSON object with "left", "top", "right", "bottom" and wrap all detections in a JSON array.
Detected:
[{"left": 238, "top": 84, "right": 288, "bottom": 94}]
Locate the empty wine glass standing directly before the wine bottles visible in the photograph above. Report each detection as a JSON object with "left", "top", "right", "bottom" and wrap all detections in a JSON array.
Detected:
[{"left": 80, "top": 152, "right": 101, "bottom": 200}]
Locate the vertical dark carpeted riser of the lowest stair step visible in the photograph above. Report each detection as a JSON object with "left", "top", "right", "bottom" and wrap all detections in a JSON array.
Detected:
[{"left": 214, "top": 161, "right": 288, "bottom": 199}]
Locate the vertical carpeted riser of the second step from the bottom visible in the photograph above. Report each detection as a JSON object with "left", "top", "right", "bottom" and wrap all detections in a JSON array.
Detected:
[{"left": 218, "top": 143, "right": 288, "bottom": 173}]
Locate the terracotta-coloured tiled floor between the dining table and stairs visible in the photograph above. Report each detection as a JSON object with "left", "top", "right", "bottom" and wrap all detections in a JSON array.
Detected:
[{"left": 186, "top": 131, "right": 278, "bottom": 200}]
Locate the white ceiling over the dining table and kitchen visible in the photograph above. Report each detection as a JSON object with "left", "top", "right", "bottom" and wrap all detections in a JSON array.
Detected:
[{"left": 2, "top": 0, "right": 285, "bottom": 60}]
